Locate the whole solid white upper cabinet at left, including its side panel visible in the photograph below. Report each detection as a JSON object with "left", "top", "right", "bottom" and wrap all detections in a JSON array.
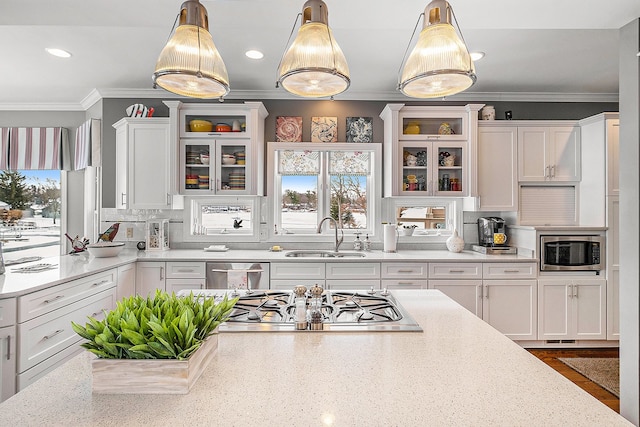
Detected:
[{"left": 113, "top": 118, "right": 175, "bottom": 209}]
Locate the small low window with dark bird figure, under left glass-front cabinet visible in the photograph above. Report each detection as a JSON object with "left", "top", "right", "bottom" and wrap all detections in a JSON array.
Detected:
[{"left": 183, "top": 196, "right": 259, "bottom": 242}]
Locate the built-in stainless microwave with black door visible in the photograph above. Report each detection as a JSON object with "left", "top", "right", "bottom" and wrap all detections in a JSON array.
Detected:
[{"left": 540, "top": 235, "right": 605, "bottom": 271}]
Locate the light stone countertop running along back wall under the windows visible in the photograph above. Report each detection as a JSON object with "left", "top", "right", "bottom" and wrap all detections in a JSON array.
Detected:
[{"left": 0, "top": 249, "right": 537, "bottom": 299}]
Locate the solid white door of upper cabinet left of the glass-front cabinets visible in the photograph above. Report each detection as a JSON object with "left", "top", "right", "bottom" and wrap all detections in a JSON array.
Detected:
[{"left": 127, "top": 119, "right": 171, "bottom": 209}]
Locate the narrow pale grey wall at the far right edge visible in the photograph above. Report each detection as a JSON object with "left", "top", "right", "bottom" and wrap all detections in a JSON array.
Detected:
[{"left": 619, "top": 19, "right": 640, "bottom": 425}]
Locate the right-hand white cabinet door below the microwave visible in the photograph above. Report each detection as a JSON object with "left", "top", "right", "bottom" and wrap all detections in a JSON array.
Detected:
[{"left": 573, "top": 279, "right": 607, "bottom": 340}]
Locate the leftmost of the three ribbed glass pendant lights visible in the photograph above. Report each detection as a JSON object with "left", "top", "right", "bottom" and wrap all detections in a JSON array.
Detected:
[{"left": 153, "top": 0, "right": 230, "bottom": 98}]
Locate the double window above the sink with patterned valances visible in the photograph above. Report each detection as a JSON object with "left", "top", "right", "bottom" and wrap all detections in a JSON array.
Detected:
[{"left": 268, "top": 143, "right": 381, "bottom": 236}]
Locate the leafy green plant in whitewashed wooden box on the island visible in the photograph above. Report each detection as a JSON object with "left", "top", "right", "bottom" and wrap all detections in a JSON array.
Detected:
[{"left": 72, "top": 290, "right": 238, "bottom": 393}]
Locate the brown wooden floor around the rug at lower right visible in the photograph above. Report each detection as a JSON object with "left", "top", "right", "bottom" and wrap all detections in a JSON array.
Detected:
[{"left": 528, "top": 348, "right": 620, "bottom": 413}]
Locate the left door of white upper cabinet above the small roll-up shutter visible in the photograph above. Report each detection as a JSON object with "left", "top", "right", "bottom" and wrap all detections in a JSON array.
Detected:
[{"left": 518, "top": 127, "right": 549, "bottom": 182}]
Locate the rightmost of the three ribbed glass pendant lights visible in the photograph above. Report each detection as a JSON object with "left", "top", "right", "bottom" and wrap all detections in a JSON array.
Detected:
[{"left": 398, "top": 0, "right": 476, "bottom": 98}]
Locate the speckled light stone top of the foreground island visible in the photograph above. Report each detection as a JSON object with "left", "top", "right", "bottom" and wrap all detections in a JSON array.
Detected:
[{"left": 0, "top": 290, "right": 632, "bottom": 427}]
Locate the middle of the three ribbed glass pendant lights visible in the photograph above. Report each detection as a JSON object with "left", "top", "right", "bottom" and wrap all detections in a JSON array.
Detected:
[{"left": 276, "top": 0, "right": 351, "bottom": 98}]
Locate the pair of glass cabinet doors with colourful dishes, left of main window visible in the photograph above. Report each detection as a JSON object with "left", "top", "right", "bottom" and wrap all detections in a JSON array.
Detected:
[{"left": 180, "top": 139, "right": 256, "bottom": 195}]
